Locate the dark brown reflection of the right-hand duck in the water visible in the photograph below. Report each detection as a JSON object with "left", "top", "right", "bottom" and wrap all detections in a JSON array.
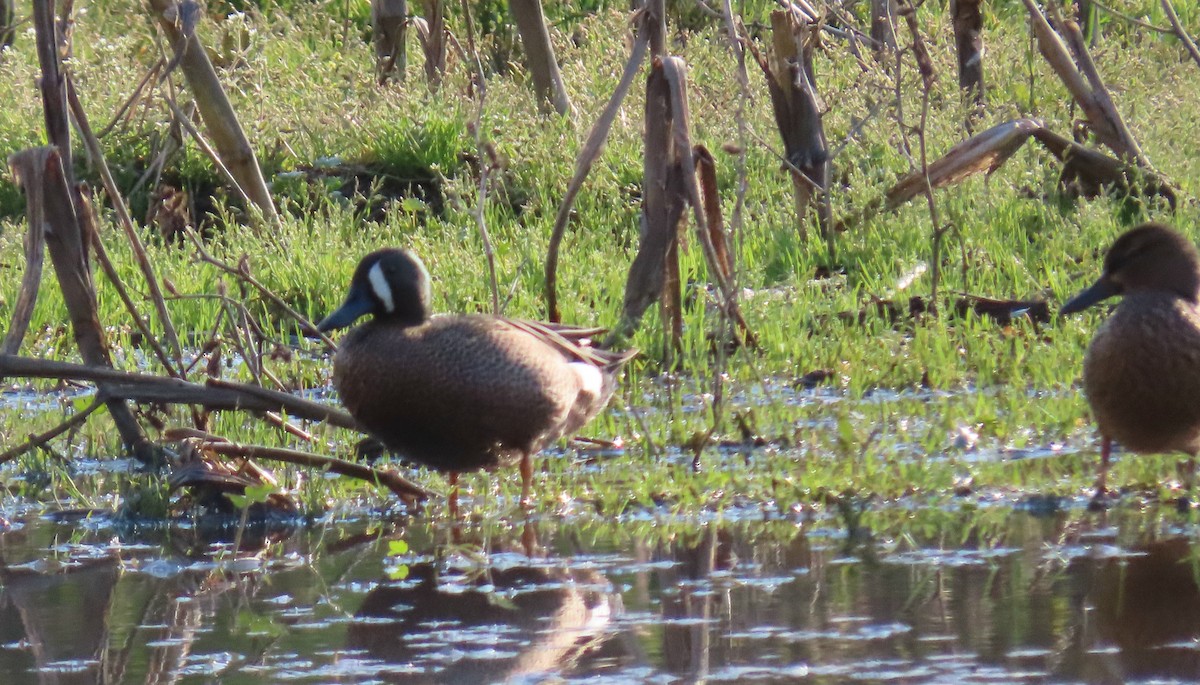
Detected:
[{"left": 1061, "top": 537, "right": 1200, "bottom": 684}]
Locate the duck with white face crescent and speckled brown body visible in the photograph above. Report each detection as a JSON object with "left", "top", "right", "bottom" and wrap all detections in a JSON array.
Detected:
[{"left": 318, "top": 248, "right": 636, "bottom": 506}]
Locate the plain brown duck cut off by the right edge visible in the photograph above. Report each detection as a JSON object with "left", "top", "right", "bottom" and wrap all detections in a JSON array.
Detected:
[{"left": 1062, "top": 223, "right": 1200, "bottom": 501}]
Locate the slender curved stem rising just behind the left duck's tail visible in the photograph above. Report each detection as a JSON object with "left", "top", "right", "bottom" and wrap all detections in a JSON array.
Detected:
[{"left": 546, "top": 6, "right": 654, "bottom": 323}]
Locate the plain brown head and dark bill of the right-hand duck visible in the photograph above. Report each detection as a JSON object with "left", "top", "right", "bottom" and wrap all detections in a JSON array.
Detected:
[{"left": 1058, "top": 223, "right": 1200, "bottom": 314}]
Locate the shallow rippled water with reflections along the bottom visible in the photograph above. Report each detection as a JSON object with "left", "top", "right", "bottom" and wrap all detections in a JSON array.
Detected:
[{"left": 0, "top": 500, "right": 1200, "bottom": 683}]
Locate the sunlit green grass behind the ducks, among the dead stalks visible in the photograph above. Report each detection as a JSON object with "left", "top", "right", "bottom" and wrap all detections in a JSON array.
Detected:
[{"left": 0, "top": 0, "right": 1200, "bottom": 513}]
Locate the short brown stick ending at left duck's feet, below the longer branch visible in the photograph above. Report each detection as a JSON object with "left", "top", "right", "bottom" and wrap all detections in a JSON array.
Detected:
[{"left": 163, "top": 428, "right": 433, "bottom": 504}]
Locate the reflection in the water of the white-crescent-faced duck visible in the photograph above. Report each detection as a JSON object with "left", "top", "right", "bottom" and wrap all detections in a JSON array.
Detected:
[{"left": 347, "top": 525, "right": 620, "bottom": 683}]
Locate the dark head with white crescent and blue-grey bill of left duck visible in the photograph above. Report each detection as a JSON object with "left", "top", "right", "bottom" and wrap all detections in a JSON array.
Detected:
[{"left": 317, "top": 247, "right": 430, "bottom": 332}]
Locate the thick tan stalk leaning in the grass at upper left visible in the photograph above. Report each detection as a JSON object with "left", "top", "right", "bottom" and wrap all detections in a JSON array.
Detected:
[{"left": 149, "top": 0, "right": 280, "bottom": 224}]
